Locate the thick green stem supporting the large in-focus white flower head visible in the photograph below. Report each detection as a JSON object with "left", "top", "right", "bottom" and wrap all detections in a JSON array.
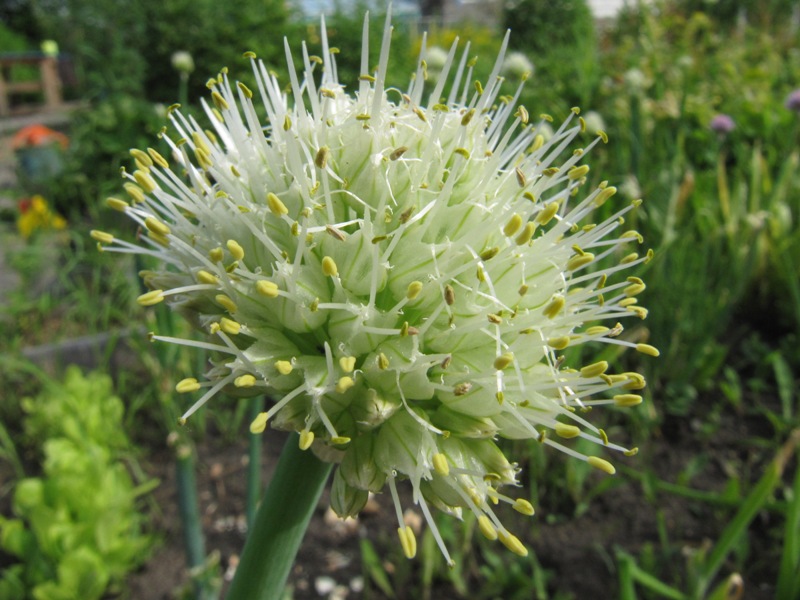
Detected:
[{"left": 228, "top": 433, "right": 331, "bottom": 600}]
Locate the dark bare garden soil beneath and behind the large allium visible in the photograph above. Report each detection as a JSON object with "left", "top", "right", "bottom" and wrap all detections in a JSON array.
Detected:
[{"left": 120, "top": 390, "right": 788, "bottom": 600}]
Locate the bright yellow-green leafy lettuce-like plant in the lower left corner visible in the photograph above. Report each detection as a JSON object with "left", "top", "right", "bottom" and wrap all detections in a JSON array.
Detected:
[{"left": 0, "top": 367, "right": 154, "bottom": 600}]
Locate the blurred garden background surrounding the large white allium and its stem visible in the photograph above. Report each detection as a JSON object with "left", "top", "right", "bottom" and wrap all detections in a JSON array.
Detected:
[{"left": 0, "top": 0, "right": 800, "bottom": 600}]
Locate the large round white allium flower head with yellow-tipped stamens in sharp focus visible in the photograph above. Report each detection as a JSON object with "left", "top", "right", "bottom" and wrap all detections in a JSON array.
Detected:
[{"left": 93, "top": 10, "right": 657, "bottom": 561}]
